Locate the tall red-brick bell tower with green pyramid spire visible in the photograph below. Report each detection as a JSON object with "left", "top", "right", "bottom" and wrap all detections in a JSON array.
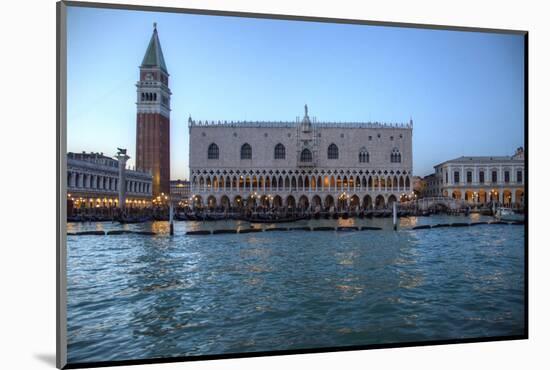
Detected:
[{"left": 136, "top": 23, "right": 172, "bottom": 197}]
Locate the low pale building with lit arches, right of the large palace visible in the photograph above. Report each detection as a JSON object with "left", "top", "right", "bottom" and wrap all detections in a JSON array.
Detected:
[{"left": 427, "top": 147, "right": 525, "bottom": 206}]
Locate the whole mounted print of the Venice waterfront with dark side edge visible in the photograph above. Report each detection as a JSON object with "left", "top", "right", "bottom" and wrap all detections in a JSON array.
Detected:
[{"left": 58, "top": 2, "right": 528, "bottom": 368}]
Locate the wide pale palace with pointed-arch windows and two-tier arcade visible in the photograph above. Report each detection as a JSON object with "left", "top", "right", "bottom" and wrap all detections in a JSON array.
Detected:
[{"left": 189, "top": 105, "right": 413, "bottom": 210}]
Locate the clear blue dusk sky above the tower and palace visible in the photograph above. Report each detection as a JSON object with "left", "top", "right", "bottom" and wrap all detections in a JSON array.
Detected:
[{"left": 67, "top": 7, "right": 524, "bottom": 179}]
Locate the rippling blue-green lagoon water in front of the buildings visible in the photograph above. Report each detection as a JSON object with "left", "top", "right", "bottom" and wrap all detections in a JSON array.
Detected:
[{"left": 67, "top": 215, "right": 524, "bottom": 363}]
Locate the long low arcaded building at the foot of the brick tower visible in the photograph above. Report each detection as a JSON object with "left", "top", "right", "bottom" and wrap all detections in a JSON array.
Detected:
[{"left": 67, "top": 152, "right": 152, "bottom": 208}]
